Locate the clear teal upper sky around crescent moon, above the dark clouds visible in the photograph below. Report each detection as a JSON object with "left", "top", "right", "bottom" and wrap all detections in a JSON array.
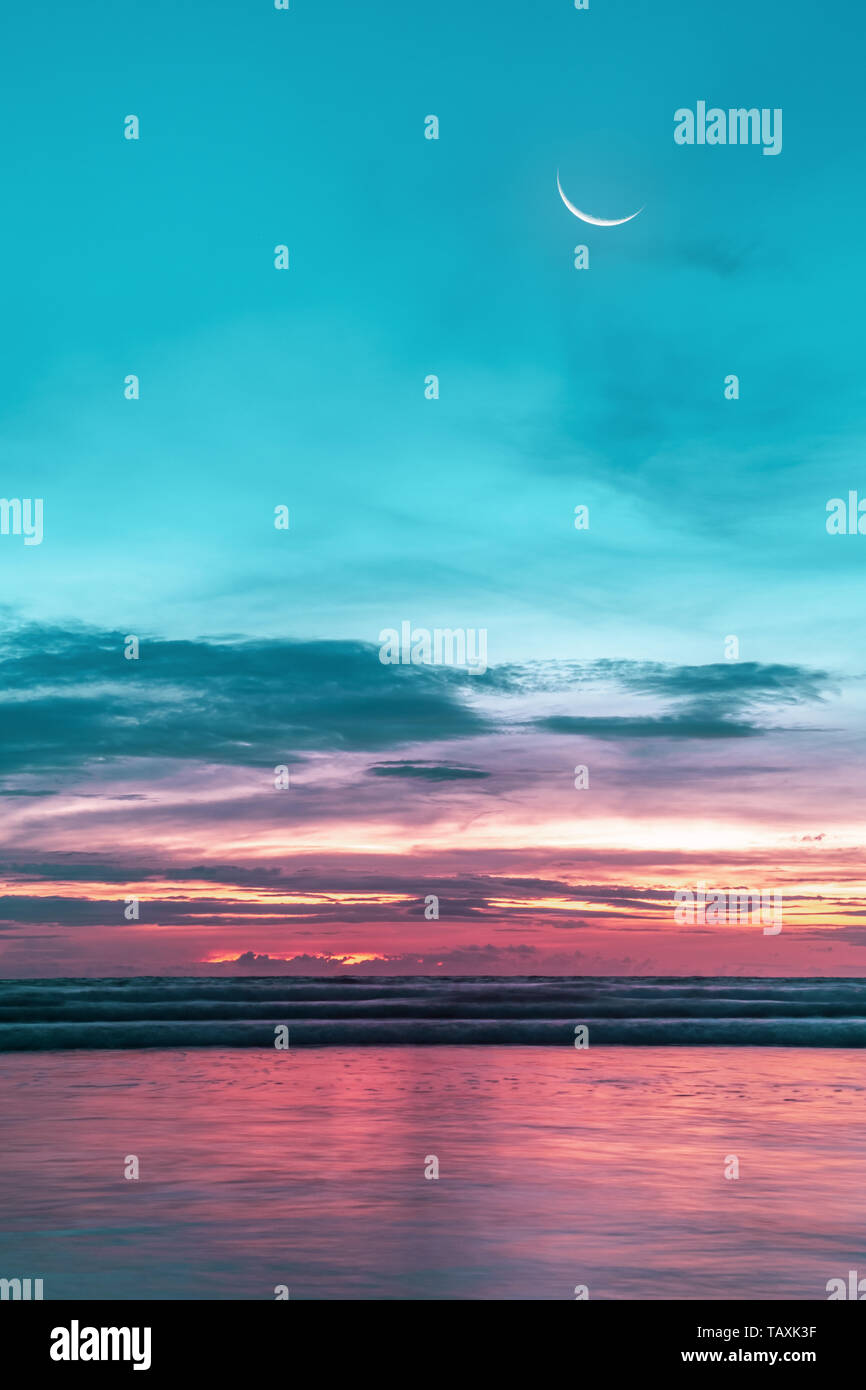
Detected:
[{"left": 0, "top": 0, "right": 865, "bottom": 666}]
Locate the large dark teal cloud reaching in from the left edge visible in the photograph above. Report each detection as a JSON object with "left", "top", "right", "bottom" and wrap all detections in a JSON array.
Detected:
[{"left": 0, "top": 624, "right": 489, "bottom": 791}]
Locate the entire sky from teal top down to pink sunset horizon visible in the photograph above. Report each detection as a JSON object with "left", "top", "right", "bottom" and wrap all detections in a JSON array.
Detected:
[{"left": 0, "top": 0, "right": 866, "bottom": 977}]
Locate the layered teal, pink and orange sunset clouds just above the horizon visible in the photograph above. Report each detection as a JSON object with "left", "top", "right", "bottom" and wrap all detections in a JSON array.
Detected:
[{"left": 0, "top": 624, "right": 862, "bottom": 973}]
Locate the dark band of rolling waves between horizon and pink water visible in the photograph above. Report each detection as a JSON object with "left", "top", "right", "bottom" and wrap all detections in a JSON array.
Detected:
[{"left": 0, "top": 976, "right": 866, "bottom": 1052}]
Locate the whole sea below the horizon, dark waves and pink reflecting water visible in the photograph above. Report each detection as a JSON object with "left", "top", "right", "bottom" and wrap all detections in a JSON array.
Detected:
[{"left": 0, "top": 980, "right": 866, "bottom": 1301}]
